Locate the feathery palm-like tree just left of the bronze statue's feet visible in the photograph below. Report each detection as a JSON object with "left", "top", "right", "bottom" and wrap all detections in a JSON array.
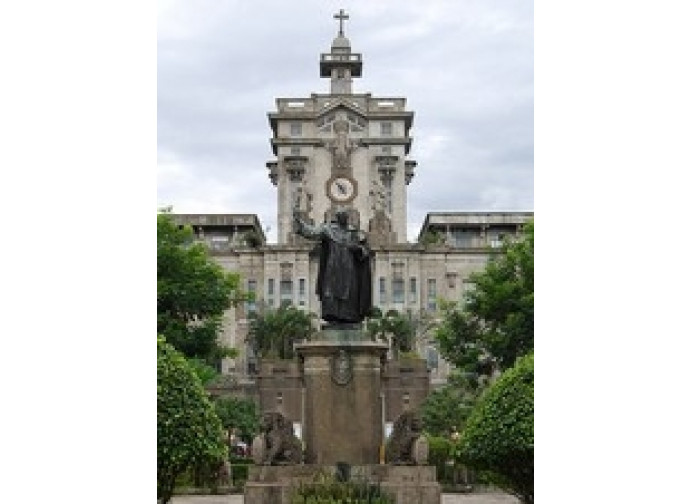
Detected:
[{"left": 247, "top": 305, "right": 316, "bottom": 359}]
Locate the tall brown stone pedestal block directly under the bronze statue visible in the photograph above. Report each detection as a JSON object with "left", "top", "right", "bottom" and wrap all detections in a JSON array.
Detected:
[{"left": 295, "top": 338, "right": 388, "bottom": 465}]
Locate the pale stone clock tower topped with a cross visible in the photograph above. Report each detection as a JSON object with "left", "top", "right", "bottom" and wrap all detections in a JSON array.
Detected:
[{"left": 266, "top": 9, "right": 416, "bottom": 245}]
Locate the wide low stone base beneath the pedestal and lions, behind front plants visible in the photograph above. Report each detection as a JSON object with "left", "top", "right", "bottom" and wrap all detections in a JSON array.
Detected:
[{"left": 244, "top": 465, "right": 441, "bottom": 504}]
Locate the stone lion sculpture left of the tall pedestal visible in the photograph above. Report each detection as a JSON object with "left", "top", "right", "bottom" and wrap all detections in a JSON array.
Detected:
[{"left": 252, "top": 411, "right": 302, "bottom": 465}]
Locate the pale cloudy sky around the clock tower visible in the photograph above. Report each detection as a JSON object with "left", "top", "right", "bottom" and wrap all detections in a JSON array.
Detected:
[{"left": 157, "top": 0, "right": 534, "bottom": 241}]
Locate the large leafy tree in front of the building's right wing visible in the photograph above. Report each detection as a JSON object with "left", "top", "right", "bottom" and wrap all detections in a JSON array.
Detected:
[{"left": 436, "top": 222, "right": 534, "bottom": 375}]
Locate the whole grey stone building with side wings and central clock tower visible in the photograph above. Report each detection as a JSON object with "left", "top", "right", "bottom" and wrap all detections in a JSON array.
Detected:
[{"left": 169, "top": 12, "right": 533, "bottom": 421}]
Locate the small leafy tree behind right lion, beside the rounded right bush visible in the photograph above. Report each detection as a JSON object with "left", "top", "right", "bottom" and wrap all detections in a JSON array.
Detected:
[{"left": 421, "top": 373, "right": 482, "bottom": 436}]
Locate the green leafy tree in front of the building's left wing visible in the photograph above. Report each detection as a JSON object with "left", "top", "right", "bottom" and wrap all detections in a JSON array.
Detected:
[{"left": 157, "top": 212, "right": 245, "bottom": 367}]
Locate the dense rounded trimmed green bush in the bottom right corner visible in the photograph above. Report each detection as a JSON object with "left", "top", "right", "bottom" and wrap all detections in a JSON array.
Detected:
[{"left": 457, "top": 354, "right": 534, "bottom": 504}]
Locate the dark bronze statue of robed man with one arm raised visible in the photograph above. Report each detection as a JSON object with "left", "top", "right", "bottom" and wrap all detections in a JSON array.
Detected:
[{"left": 293, "top": 210, "right": 371, "bottom": 324}]
